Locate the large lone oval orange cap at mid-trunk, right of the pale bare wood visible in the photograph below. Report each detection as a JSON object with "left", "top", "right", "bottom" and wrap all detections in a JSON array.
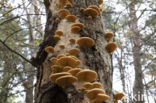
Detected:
[{"left": 77, "top": 37, "right": 95, "bottom": 48}]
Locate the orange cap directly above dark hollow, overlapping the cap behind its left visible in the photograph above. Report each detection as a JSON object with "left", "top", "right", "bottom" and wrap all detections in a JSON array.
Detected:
[{"left": 56, "top": 75, "right": 77, "bottom": 87}]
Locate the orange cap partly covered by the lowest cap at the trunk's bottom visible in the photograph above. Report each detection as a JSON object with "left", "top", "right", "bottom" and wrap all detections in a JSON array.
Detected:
[{"left": 86, "top": 88, "right": 105, "bottom": 100}]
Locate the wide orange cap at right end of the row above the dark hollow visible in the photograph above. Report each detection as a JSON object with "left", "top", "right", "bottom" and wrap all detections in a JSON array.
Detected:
[{"left": 76, "top": 69, "right": 97, "bottom": 82}]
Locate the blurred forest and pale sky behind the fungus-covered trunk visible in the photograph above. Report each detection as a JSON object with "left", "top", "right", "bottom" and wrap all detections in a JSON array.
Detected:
[{"left": 0, "top": 0, "right": 156, "bottom": 103}]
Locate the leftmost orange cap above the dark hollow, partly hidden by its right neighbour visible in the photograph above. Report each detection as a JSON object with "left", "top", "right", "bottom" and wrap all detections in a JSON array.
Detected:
[{"left": 49, "top": 72, "right": 71, "bottom": 83}]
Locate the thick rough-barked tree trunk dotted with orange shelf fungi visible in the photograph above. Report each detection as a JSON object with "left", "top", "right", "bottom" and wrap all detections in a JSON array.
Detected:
[{"left": 33, "top": 0, "right": 113, "bottom": 103}]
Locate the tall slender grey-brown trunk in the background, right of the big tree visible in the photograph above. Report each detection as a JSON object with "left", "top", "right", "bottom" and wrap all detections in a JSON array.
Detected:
[{"left": 129, "top": 0, "right": 144, "bottom": 103}]
